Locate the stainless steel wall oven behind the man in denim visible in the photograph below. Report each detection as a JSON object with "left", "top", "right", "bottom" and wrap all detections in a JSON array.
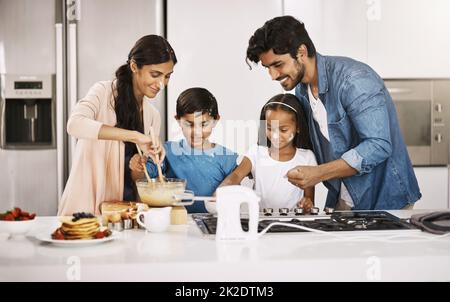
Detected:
[{"left": 385, "top": 79, "right": 450, "bottom": 166}]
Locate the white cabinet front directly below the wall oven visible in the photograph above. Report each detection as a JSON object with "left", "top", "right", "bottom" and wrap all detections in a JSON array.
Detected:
[{"left": 414, "top": 167, "right": 449, "bottom": 209}]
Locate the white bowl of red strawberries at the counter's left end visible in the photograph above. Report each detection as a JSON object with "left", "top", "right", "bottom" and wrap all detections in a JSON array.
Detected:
[{"left": 0, "top": 208, "right": 36, "bottom": 236}]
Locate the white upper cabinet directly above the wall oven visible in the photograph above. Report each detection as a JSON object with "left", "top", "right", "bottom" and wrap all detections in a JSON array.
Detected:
[{"left": 367, "top": 0, "right": 450, "bottom": 78}]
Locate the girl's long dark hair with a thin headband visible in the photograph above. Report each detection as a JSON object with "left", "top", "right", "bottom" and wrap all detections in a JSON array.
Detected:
[{"left": 258, "top": 93, "right": 311, "bottom": 149}]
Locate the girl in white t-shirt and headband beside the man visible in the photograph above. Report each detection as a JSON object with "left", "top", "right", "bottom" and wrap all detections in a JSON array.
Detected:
[{"left": 220, "top": 94, "right": 317, "bottom": 212}]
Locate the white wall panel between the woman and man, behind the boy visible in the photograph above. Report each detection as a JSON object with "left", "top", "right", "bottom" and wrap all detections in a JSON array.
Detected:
[{"left": 167, "top": 0, "right": 282, "bottom": 153}]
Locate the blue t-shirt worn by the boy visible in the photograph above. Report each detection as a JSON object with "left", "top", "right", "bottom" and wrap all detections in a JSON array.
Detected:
[{"left": 147, "top": 139, "right": 238, "bottom": 213}]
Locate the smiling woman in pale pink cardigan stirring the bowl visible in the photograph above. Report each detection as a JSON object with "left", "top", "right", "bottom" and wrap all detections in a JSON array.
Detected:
[{"left": 58, "top": 35, "right": 177, "bottom": 215}]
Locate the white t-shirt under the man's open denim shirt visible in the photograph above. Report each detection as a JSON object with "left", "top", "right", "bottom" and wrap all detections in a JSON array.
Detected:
[{"left": 308, "top": 85, "right": 354, "bottom": 207}]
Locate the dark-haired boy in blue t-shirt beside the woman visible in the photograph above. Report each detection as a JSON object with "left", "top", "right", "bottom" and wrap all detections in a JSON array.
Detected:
[{"left": 130, "top": 88, "right": 237, "bottom": 213}]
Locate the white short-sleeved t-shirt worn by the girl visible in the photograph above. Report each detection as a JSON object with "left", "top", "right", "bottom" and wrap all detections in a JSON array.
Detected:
[{"left": 244, "top": 145, "right": 317, "bottom": 209}]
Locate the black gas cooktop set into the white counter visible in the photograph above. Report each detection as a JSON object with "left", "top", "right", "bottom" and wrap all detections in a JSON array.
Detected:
[{"left": 192, "top": 211, "right": 415, "bottom": 234}]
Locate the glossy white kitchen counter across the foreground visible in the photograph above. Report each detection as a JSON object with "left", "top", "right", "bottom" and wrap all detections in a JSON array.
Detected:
[{"left": 0, "top": 211, "right": 450, "bottom": 281}]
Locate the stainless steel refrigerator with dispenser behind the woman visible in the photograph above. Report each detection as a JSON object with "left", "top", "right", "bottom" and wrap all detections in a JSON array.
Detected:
[{"left": 0, "top": 0, "right": 166, "bottom": 215}]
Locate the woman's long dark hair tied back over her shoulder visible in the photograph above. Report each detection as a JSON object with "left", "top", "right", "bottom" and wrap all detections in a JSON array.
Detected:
[{"left": 114, "top": 35, "right": 177, "bottom": 132}]
